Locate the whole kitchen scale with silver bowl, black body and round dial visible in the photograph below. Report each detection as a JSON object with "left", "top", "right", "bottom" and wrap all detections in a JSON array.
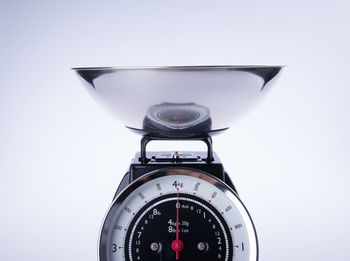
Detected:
[{"left": 74, "top": 66, "right": 282, "bottom": 261}]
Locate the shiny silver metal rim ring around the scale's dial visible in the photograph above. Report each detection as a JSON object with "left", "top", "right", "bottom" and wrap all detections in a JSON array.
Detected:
[{"left": 98, "top": 167, "right": 258, "bottom": 261}]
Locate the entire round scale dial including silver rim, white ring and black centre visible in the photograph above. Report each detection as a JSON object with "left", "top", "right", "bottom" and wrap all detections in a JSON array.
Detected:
[{"left": 99, "top": 168, "right": 257, "bottom": 261}]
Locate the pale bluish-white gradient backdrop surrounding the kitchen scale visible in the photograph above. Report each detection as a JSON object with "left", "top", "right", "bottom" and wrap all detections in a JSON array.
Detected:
[{"left": 0, "top": 0, "right": 350, "bottom": 261}]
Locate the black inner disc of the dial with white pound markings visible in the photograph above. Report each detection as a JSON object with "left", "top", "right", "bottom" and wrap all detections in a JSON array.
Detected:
[{"left": 124, "top": 193, "right": 233, "bottom": 261}]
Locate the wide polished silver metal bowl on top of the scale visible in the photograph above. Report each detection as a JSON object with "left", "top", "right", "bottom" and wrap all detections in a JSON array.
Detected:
[{"left": 74, "top": 66, "right": 282, "bottom": 137}]
